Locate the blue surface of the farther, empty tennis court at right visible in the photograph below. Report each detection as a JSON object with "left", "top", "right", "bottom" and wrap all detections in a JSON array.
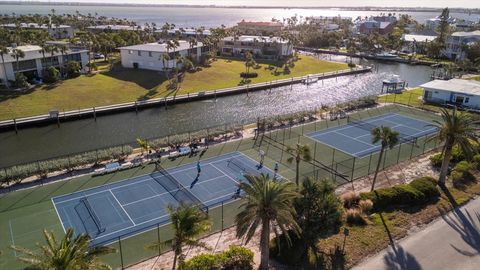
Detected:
[{"left": 307, "top": 113, "right": 437, "bottom": 157}]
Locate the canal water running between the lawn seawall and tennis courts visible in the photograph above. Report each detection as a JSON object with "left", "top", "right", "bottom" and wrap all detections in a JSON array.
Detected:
[{"left": 0, "top": 56, "right": 431, "bottom": 168}]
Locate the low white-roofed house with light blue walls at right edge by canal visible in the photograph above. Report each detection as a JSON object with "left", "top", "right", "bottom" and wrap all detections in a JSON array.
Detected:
[{"left": 421, "top": 79, "right": 480, "bottom": 109}]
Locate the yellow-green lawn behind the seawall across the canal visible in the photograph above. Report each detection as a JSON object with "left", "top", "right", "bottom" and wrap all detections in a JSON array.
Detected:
[{"left": 0, "top": 56, "right": 347, "bottom": 120}]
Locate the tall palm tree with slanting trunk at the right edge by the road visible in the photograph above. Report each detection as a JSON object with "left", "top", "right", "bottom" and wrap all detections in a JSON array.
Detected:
[{"left": 432, "top": 108, "right": 480, "bottom": 186}]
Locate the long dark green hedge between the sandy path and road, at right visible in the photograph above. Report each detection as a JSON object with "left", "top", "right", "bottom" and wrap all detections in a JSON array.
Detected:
[{"left": 360, "top": 177, "right": 440, "bottom": 211}]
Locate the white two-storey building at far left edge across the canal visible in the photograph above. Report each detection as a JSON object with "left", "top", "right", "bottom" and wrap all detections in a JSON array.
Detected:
[{"left": 0, "top": 45, "right": 88, "bottom": 85}]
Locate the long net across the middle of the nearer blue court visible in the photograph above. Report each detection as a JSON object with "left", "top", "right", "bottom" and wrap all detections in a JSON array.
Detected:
[{"left": 151, "top": 162, "right": 208, "bottom": 212}]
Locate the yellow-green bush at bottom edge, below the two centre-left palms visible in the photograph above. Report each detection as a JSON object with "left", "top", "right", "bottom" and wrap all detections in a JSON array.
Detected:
[{"left": 182, "top": 246, "right": 253, "bottom": 270}]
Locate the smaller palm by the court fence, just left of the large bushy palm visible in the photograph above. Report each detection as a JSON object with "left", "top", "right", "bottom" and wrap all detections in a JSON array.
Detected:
[{"left": 147, "top": 201, "right": 211, "bottom": 270}]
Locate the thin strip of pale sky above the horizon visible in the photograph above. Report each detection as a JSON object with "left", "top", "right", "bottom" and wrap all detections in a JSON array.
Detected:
[{"left": 0, "top": 0, "right": 480, "bottom": 8}]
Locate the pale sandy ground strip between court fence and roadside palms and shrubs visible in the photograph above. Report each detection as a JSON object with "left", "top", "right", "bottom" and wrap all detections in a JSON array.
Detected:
[{"left": 127, "top": 154, "right": 438, "bottom": 270}]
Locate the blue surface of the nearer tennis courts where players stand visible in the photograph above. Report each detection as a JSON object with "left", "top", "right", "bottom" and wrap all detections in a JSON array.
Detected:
[{"left": 52, "top": 152, "right": 273, "bottom": 245}]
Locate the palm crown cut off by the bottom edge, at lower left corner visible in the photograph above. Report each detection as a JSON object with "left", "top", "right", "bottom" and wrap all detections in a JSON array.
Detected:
[{"left": 12, "top": 228, "right": 116, "bottom": 270}]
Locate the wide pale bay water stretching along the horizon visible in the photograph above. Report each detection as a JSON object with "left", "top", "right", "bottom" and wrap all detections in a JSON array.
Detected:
[{"left": 0, "top": 5, "right": 480, "bottom": 28}]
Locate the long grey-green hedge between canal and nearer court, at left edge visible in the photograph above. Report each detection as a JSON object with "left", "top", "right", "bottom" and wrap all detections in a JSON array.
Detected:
[{"left": 0, "top": 145, "right": 133, "bottom": 185}]
